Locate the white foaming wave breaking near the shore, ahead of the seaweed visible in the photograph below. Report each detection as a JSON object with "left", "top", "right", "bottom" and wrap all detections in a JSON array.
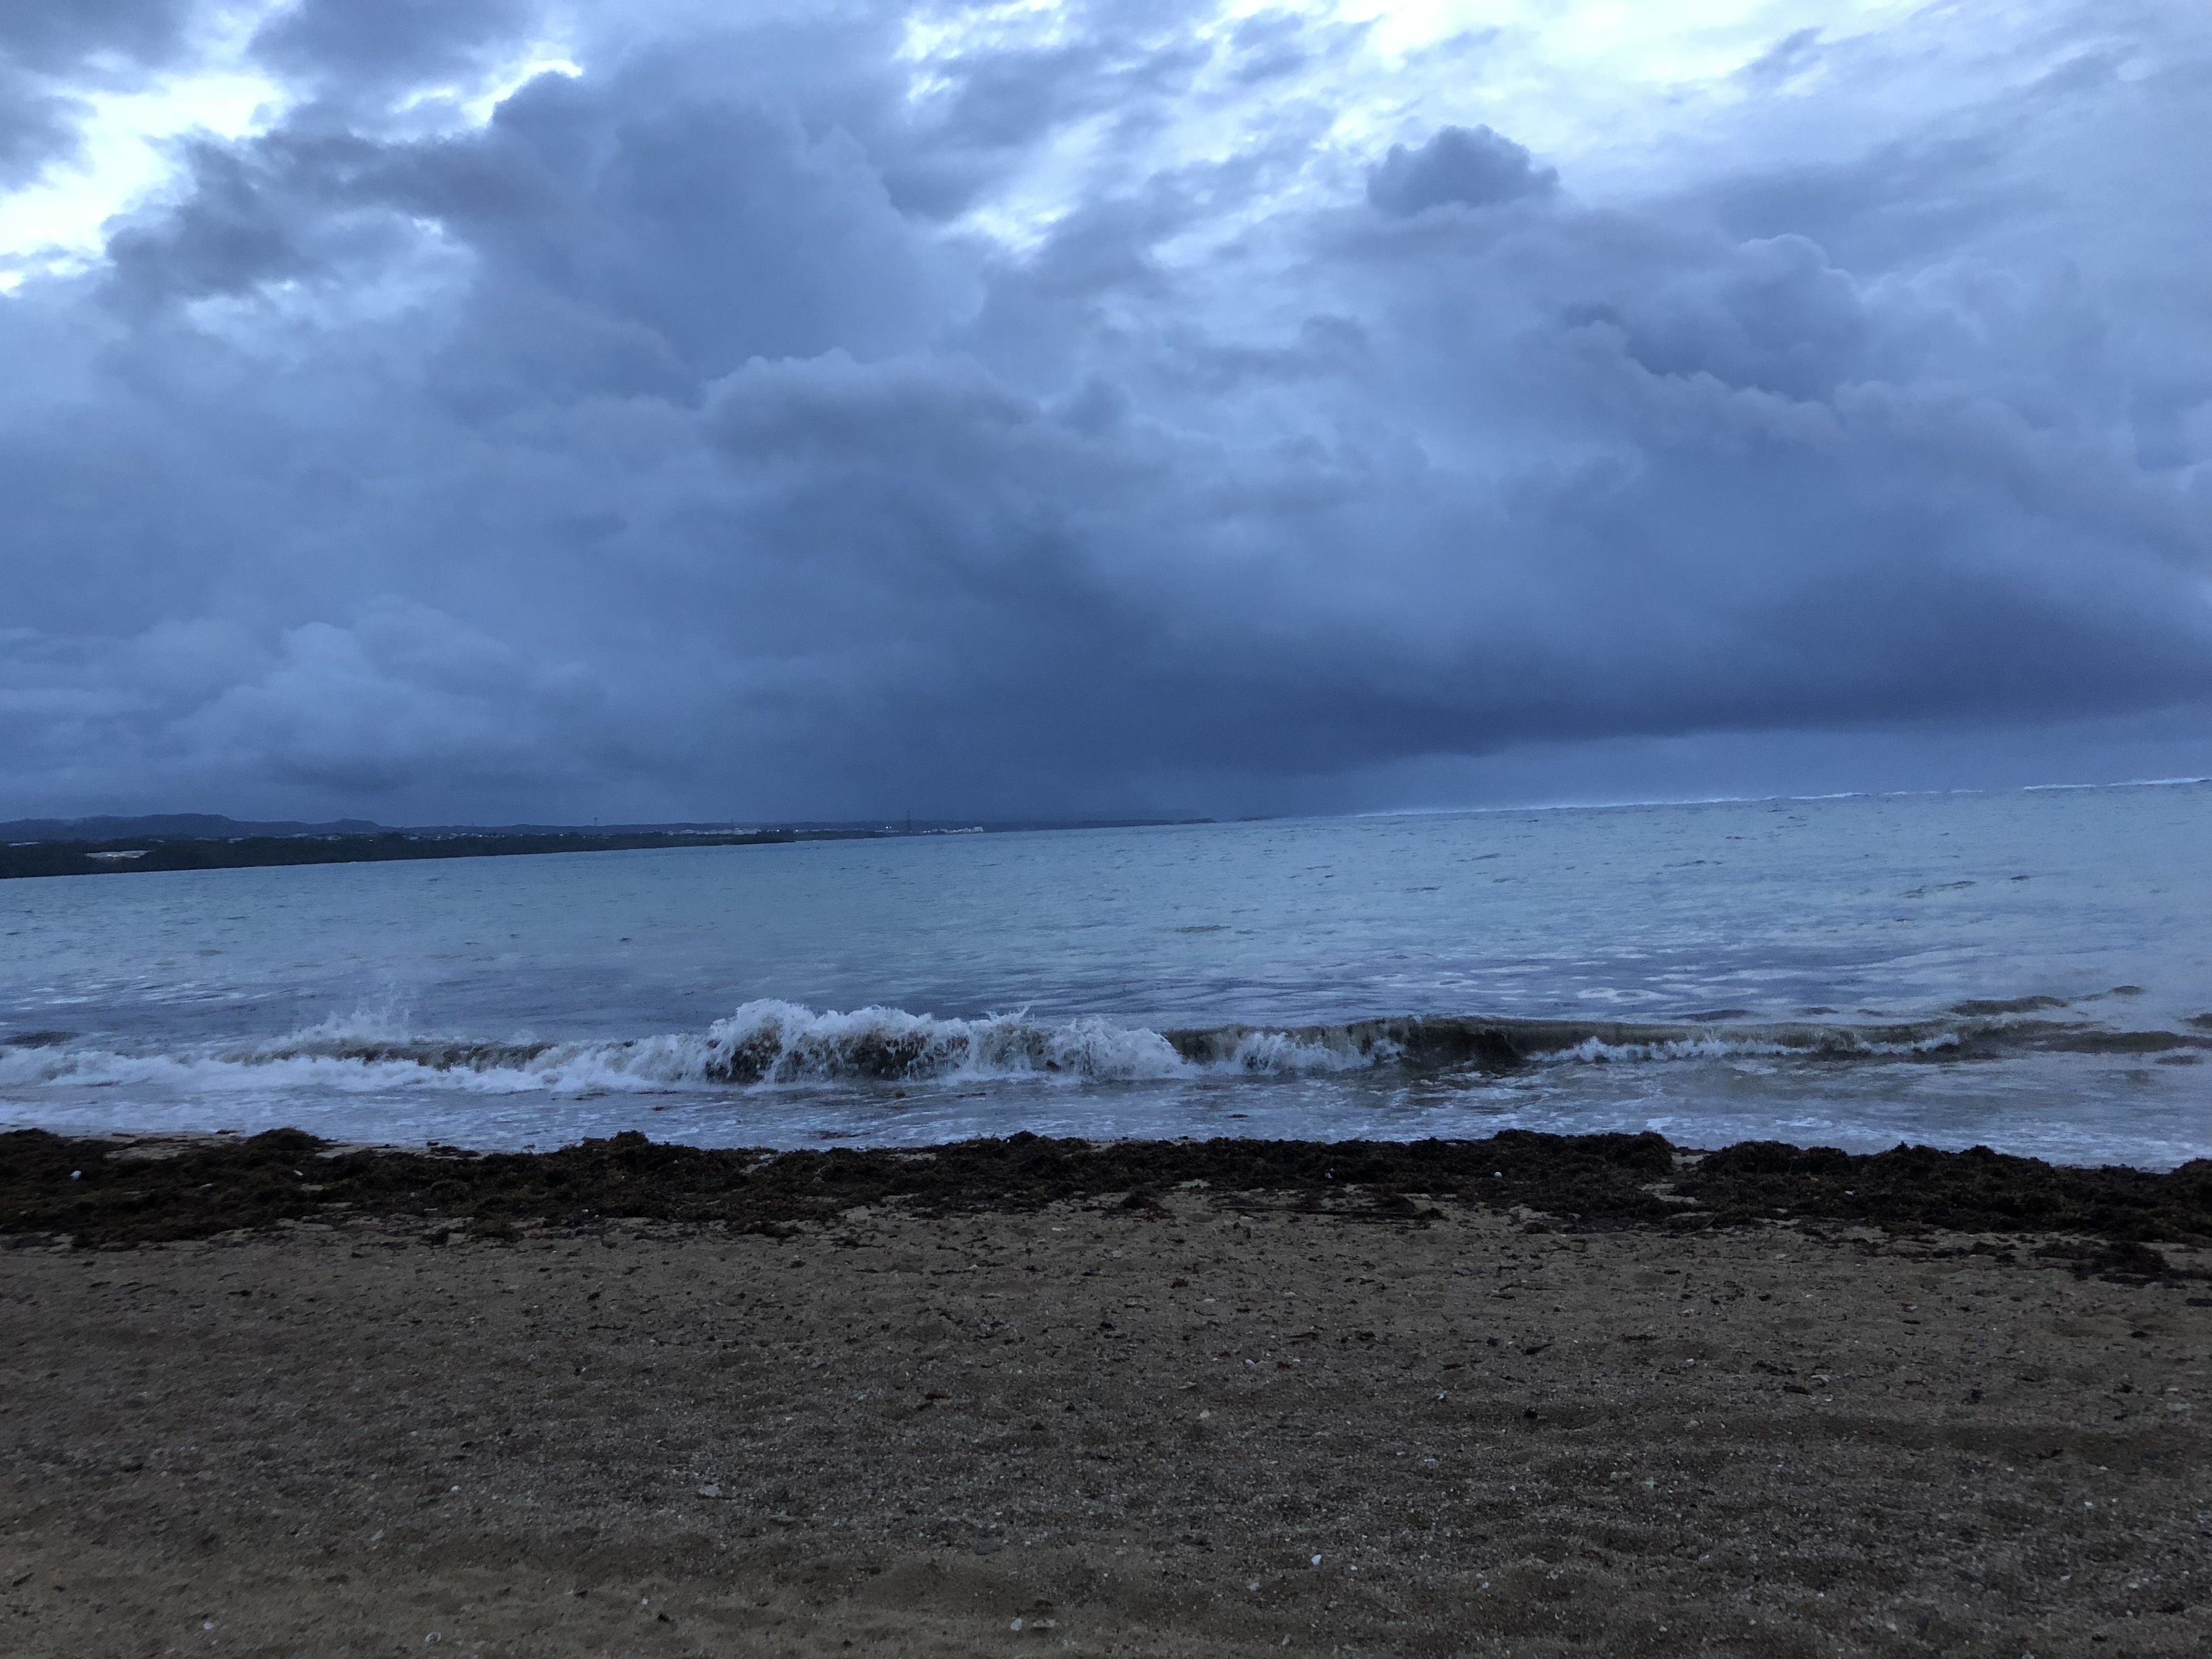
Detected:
[{"left": 0, "top": 1000, "right": 2212, "bottom": 1093}]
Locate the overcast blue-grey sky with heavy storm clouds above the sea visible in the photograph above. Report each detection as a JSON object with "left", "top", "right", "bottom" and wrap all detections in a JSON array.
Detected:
[{"left": 0, "top": 0, "right": 2212, "bottom": 823}]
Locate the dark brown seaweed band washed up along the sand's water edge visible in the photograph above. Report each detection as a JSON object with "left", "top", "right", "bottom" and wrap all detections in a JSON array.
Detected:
[{"left": 13, "top": 1128, "right": 2212, "bottom": 1269}]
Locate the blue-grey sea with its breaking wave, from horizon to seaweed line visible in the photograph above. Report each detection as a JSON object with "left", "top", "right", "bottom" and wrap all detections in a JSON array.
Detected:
[{"left": 0, "top": 783, "right": 2212, "bottom": 1168}]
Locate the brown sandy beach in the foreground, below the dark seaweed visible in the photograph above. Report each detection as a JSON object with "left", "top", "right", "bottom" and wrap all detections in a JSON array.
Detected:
[{"left": 0, "top": 1192, "right": 2212, "bottom": 1659}]
